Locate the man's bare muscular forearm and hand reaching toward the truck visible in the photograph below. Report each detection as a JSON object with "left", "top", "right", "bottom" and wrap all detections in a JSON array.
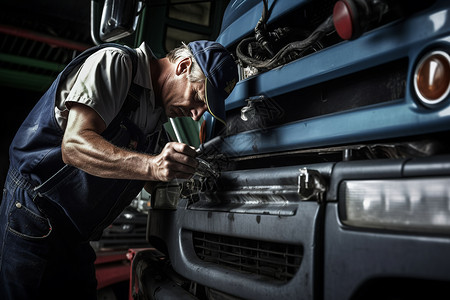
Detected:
[{"left": 61, "top": 104, "right": 197, "bottom": 181}]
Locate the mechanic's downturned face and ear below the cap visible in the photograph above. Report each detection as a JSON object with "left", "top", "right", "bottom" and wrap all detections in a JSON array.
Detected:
[{"left": 161, "top": 59, "right": 207, "bottom": 121}]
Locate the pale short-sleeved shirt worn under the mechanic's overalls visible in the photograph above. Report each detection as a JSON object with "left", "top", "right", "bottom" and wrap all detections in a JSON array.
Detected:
[{"left": 55, "top": 43, "right": 166, "bottom": 135}]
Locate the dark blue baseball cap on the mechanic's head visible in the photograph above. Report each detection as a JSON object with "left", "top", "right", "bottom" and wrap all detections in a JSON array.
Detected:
[{"left": 188, "top": 40, "right": 239, "bottom": 124}]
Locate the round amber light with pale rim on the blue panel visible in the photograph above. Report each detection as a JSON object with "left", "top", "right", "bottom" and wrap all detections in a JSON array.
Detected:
[{"left": 414, "top": 50, "right": 450, "bottom": 105}]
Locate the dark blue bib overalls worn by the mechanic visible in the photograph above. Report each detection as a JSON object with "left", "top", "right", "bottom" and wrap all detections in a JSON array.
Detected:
[{"left": 0, "top": 44, "right": 163, "bottom": 300}]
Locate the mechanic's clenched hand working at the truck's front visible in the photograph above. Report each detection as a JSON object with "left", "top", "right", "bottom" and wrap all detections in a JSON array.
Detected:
[{"left": 151, "top": 143, "right": 198, "bottom": 181}]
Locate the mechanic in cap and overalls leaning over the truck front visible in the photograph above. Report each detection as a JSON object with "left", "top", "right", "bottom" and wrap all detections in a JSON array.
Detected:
[{"left": 0, "top": 41, "right": 238, "bottom": 300}]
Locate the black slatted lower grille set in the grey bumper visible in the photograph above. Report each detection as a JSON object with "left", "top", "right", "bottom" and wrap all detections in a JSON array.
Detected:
[{"left": 192, "top": 232, "right": 303, "bottom": 282}]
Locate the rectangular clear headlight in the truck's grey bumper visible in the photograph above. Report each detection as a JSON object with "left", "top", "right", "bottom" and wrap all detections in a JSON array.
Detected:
[{"left": 340, "top": 177, "right": 450, "bottom": 233}]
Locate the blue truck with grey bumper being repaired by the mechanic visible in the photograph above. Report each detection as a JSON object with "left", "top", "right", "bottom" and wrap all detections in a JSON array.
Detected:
[{"left": 125, "top": 0, "right": 450, "bottom": 299}]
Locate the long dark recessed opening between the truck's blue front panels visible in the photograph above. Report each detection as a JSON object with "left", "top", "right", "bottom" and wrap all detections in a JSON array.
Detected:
[{"left": 227, "top": 58, "right": 408, "bottom": 135}]
